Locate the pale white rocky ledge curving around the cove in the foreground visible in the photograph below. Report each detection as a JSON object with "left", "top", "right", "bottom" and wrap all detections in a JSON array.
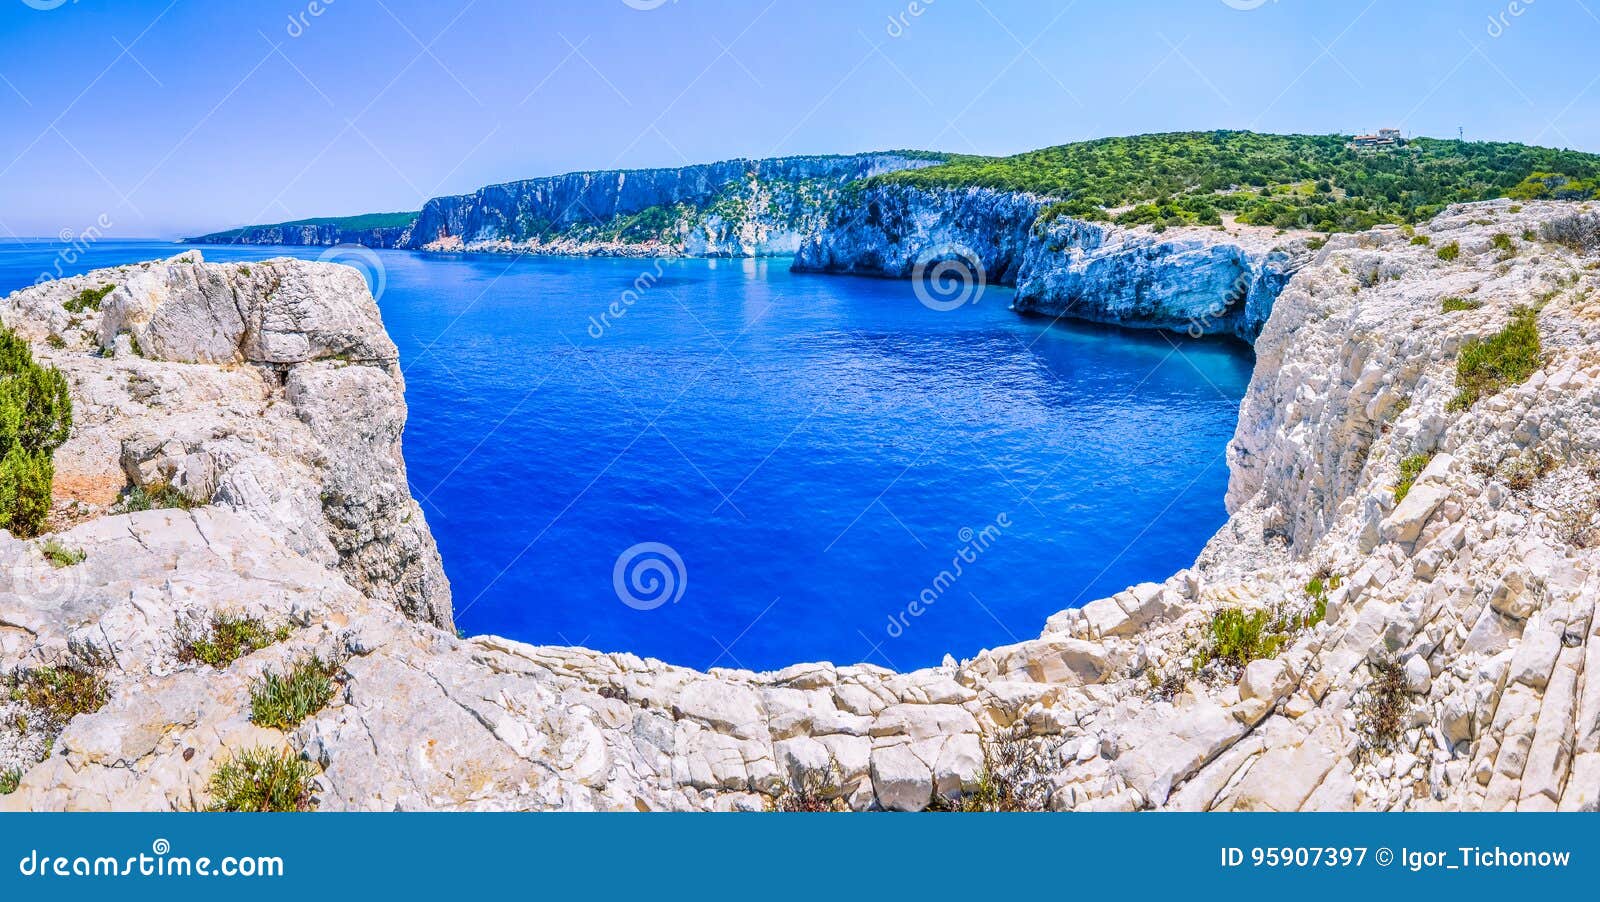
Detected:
[{"left": 0, "top": 202, "right": 1600, "bottom": 811}]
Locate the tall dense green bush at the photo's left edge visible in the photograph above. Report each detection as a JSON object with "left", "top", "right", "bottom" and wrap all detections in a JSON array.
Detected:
[{"left": 0, "top": 326, "right": 72, "bottom": 537}]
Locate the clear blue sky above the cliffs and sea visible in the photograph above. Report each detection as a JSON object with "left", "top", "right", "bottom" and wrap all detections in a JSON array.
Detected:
[{"left": 0, "top": 0, "right": 1600, "bottom": 238}]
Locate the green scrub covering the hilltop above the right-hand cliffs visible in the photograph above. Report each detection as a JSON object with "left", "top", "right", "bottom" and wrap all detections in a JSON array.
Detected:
[{"left": 869, "top": 131, "right": 1600, "bottom": 232}]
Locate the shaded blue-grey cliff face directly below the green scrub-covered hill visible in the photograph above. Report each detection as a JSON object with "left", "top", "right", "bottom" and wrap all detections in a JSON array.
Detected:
[{"left": 794, "top": 186, "right": 1309, "bottom": 341}]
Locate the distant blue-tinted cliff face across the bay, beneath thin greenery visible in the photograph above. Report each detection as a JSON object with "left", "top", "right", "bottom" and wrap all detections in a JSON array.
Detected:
[{"left": 405, "top": 154, "right": 934, "bottom": 256}]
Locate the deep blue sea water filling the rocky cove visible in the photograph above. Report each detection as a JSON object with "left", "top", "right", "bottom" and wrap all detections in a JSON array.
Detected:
[{"left": 0, "top": 241, "right": 1251, "bottom": 669}]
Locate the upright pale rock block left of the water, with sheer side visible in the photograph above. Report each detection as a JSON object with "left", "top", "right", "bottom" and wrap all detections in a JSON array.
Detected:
[{"left": 3, "top": 251, "right": 451, "bottom": 627}]
